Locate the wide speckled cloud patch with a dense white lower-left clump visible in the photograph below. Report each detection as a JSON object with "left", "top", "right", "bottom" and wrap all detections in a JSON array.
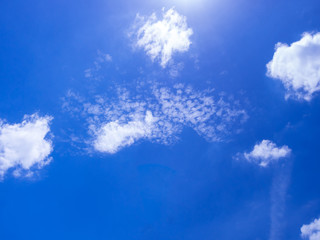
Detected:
[{"left": 68, "top": 84, "right": 247, "bottom": 153}]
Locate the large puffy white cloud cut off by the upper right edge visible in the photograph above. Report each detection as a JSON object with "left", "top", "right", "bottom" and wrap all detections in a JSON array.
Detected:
[{"left": 267, "top": 33, "right": 320, "bottom": 101}]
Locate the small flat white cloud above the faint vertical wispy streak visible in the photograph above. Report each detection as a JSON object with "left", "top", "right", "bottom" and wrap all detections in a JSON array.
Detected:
[{"left": 244, "top": 140, "right": 291, "bottom": 167}]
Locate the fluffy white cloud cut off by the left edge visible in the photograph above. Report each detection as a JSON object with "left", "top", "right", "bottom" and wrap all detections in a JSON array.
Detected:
[{"left": 0, "top": 114, "right": 53, "bottom": 178}]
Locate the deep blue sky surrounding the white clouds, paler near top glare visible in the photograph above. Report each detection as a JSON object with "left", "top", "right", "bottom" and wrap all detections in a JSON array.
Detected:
[{"left": 0, "top": 0, "right": 320, "bottom": 240}]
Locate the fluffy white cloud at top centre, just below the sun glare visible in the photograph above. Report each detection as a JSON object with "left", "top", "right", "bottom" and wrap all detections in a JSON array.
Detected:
[{"left": 134, "top": 8, "right": 193, "bottom": 68}]
